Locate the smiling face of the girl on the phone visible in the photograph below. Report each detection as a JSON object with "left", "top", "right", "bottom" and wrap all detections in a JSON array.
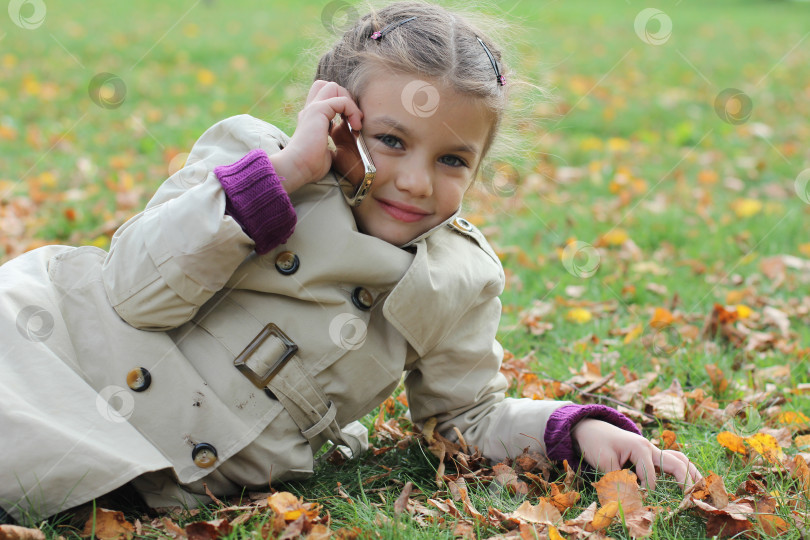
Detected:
[{"left": 352, "top": 73, "right": 492, "bottom": 246}]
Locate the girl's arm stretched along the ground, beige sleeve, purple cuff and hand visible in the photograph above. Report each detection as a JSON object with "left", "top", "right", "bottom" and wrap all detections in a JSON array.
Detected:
[{"left": 405, "top": 245, "right": 700, "bottom": 487}]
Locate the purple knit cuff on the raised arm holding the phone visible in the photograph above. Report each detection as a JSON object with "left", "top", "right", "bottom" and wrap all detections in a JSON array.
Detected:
[{"left": 214, "top": 149, "right": 296, "bottom": 255}]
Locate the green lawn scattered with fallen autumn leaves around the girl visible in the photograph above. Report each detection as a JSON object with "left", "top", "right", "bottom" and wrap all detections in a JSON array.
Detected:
[{"left": 0, "top": 0, "right": 810, "bottom": 538}]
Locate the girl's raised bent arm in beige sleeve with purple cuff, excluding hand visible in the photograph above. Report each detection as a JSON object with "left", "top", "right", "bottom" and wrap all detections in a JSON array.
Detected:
[{"left": 102, "top": 115, "right": 295, "bottom": 330}]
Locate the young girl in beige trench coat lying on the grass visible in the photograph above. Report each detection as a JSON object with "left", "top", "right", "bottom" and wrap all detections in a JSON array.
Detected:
[{"left": 0, "top": 2, "right": 700, "bottom": 519}]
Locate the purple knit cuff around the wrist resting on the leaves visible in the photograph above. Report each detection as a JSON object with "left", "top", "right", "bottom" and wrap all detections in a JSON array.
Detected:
[{"left": 543, "top": 404, "right": 641, "bottom": 467}]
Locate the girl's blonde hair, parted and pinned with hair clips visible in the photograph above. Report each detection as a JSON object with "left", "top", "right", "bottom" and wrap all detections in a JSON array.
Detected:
[{"left": 315, "top": 1, "right": 512, "bottom": 173}]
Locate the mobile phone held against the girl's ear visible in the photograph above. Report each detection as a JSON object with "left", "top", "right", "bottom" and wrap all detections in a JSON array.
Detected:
[{"left": 329, "top": 114, "right": 377, "bottom": 206}]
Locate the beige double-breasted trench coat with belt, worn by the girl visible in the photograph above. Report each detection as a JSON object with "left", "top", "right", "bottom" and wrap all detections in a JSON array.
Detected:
[{"left": 0, "top": 115, "right": 567, "bottom": 518}]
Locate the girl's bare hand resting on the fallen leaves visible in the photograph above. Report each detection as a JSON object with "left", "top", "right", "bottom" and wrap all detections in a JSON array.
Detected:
[{"left": 571, "top": 418, "right": 702, "bottom": 490}]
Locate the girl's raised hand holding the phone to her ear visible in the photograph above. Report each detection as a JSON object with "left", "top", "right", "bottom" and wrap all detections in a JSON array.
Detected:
[{"left": 270, "top": 80, "right": 363, "bottom": 193}]
